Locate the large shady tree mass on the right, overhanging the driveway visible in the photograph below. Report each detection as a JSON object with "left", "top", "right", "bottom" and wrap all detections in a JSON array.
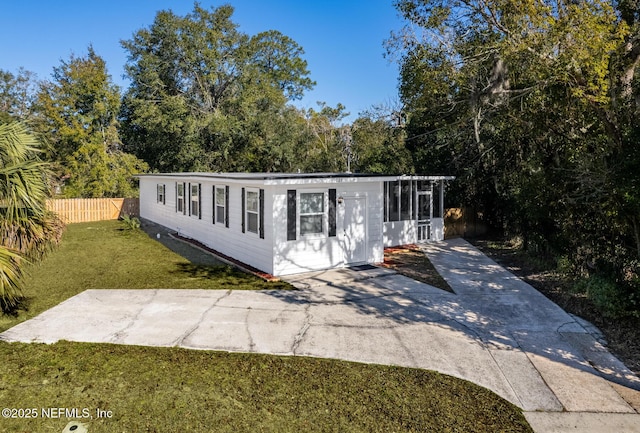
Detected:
[{"left": 389, "top": 0, "right": 640, "bottom": 312}]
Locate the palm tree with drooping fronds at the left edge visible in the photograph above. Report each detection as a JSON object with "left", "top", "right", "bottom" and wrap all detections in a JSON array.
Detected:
[{"left": 0, "top": 122, "right": 63, "bottom": 311}]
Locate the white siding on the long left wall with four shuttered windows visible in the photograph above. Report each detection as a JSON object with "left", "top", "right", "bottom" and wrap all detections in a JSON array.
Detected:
[{"left": 140, "top": 176, "right": 273, "bottom": 273}]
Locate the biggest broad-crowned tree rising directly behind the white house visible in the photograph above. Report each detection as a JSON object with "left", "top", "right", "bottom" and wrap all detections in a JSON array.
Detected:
[{"left": 121, "top": 3, "right": 314, "bottom": 171}]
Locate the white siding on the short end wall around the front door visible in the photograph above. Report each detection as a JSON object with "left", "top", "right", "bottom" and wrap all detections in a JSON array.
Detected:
[{"left": 273, "top": 182, "right": 384, "bottom": 275}]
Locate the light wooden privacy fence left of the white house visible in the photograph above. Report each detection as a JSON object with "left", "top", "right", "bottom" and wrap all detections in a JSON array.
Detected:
[{"left": 47, "top": 198, "right": 140, "bottom": 224}]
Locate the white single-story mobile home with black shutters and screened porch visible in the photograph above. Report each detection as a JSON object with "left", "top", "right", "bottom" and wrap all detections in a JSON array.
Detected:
[{"left": 139, "top": 173, "right": 453, "bottom": 275}]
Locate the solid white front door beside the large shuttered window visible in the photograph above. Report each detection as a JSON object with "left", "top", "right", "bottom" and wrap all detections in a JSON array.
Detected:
[{"left": 343, "top": 197, "right": 367, "bottom": 264}]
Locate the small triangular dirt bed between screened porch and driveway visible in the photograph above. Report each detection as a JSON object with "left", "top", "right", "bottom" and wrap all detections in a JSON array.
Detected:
[{"left": 382, "top": 245, "right": 453, "bottom": 293}]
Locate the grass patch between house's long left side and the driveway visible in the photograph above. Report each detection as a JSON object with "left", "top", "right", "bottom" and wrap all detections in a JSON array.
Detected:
[{"left": 0, "top": 221, "right": 291, "bottom": 331}]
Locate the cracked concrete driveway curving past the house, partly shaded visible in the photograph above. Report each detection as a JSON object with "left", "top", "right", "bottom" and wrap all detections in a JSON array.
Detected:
[{"left": 0, "top": 239, "right": 640, "bottom": 433}]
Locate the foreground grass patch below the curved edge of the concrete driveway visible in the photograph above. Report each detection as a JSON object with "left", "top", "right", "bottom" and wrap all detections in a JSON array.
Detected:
[{"left": 0, "top": 342, "right": 531, "bottom": 433}]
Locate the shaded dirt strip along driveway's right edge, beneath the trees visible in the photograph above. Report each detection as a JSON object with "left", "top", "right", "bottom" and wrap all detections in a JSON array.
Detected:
[{"left": 472, "top": 240, "right": 640, "bottom": 375}]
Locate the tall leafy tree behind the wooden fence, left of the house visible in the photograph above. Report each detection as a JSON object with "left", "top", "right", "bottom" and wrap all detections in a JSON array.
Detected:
[{"left": 35, "top": 46, "right": 146, "bottom": 197}]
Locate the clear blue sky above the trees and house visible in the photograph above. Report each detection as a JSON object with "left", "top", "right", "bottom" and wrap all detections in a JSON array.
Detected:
[{"left": 0, "top": 0, "right": 402, "bottom": 120}]
